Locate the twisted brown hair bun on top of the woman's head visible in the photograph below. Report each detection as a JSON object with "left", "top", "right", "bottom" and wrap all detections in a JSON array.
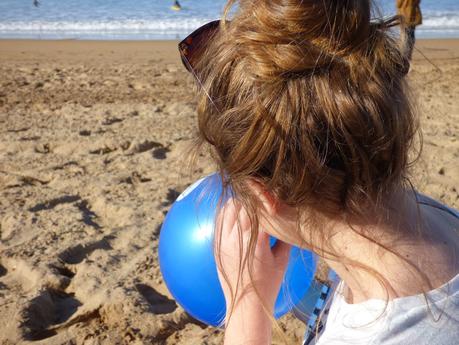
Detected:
[{"left": 233, "top": 0, "right": 384, "bottom": 79}]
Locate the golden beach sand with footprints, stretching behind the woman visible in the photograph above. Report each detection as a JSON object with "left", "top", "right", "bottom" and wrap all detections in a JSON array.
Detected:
[{"left": 0, "top": 40, "right": 459, "bottom": 345}]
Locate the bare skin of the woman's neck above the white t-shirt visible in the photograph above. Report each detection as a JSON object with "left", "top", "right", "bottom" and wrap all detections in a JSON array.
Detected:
[{"left": 325, "top": 192, "right": 457, "bottom": 303}]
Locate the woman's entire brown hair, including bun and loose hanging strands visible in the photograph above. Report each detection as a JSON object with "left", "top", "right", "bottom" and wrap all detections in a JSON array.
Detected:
[{"left": 189, "top": 0, "right": 417, "bottom": 334}]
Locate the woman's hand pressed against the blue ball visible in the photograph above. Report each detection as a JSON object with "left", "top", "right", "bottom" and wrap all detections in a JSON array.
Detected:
[{"left": 216, "top": 198, "right": 291, "bottom": 315}]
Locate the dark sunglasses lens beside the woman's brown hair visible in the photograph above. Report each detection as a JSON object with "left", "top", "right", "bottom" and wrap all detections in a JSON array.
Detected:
[{"left": 178, "top": 20, "right": 220, "bottom": 74}]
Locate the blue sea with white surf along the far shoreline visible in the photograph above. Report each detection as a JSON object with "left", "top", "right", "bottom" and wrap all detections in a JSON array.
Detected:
[{"left": 0, "top": 0, "right": 459, "bottom": 40}]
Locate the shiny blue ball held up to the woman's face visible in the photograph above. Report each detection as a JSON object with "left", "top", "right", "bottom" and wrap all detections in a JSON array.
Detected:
[{"left": 159, "top": 174, "right": 316, "bottom": 326}]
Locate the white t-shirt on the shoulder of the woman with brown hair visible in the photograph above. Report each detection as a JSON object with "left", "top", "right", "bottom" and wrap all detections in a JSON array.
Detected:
[{"left": 315, "top": 274, "right": 459, "bottom": 345}]
